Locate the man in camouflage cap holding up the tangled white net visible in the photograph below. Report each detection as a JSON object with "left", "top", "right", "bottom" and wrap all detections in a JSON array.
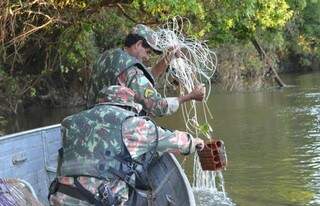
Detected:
[{"left": 88, "top": 24, "right": 205, "bottom": 116}]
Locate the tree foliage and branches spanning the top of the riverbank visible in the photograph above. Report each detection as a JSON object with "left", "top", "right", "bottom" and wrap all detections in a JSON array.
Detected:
[{"left": 0, "top": 0, "right": 320, "bottom": 113}]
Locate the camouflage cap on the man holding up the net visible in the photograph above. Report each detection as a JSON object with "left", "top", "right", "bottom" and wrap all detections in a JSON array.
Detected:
[{"left": 131, "top": 24, "right": 162, "bottom": 54}]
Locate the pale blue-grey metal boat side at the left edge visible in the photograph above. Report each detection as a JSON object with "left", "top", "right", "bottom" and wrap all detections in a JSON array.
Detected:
[{"left": 0, "top": 124, "right": 61, "bottom": 205}]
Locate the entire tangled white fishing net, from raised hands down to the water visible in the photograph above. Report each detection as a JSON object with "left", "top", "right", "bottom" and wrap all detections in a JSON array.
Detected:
[{"left": 156, "top": 17, "right": 232, "bottom": 205}]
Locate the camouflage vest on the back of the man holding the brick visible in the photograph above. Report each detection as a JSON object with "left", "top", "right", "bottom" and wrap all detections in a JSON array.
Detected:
[{"left": 59, "top": 105, "right": 135, "bottom": 178}]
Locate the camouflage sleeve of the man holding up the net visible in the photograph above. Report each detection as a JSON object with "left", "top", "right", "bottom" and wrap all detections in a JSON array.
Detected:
[{"left": 122, "top": 67, "right": 179, "bottom": 116}]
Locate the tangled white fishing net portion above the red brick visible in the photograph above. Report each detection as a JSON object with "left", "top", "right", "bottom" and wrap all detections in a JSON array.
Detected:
[{"left": 156, "top": 17, "right": 217, "bottom": 138}]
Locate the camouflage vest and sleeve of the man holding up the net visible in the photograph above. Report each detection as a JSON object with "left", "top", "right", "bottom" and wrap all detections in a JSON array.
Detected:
[{"left": 88, "top": 49, "right": 179, "bottom": 116}]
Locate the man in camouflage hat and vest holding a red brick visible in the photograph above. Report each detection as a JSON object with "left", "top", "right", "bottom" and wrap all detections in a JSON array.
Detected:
[{"left": 49, "top": 86, "right": 203, "bottom": 205}]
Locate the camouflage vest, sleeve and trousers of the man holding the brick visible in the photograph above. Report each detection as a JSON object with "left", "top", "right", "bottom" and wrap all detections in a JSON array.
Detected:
[{"left": 50, "top": 103, "right": 191, "bottom": 205}]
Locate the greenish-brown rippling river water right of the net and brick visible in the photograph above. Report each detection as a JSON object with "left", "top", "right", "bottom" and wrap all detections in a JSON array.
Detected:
[{"left": 166, "top": 74, "right": 320, "bottom": 206}]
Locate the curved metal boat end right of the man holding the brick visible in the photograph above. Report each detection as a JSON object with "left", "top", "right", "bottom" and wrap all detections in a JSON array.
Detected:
[{"left": 131, "top": 153, "right": 196, "bottom": 206}]
